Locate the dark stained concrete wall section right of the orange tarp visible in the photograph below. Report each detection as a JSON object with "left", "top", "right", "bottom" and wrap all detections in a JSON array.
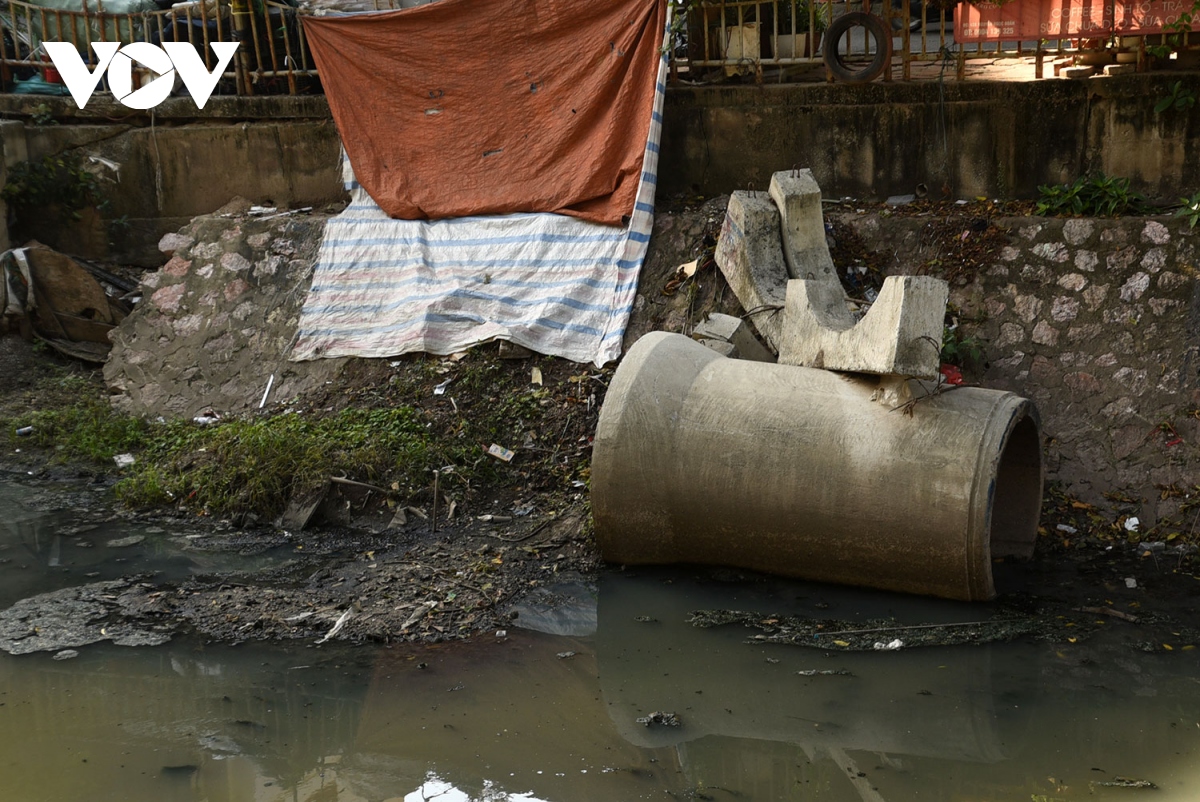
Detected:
[{"left": 659, "top": 73, "right": 1200, "bottom": 202}]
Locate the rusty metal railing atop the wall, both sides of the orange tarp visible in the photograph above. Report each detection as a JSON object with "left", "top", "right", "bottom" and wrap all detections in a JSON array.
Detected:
[{"left": 0, "top": 0, "right": 1190, "bottom": 95}]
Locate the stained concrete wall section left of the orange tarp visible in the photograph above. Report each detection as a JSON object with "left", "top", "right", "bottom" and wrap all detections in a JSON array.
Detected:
[{"left": 0, "top": 96, "right": 346, "bottom": 267}]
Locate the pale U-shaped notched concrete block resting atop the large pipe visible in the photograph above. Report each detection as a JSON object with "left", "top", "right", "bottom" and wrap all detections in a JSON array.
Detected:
[{"left": 779, "top": 276, "right": 949, "bottom": 378}]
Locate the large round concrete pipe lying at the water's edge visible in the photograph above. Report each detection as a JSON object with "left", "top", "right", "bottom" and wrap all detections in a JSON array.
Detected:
[{"left": 592, "top": 331, "right": 1042, "bottom": 600}]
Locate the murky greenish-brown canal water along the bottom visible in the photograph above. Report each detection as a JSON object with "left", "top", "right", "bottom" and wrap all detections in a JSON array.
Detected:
[{"left": 7, "top": 486, "right": 1200, "bottom": 802}]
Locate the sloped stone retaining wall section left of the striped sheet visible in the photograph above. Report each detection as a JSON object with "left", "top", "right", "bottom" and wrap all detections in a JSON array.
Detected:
[{"left": 104, "top": 214, "right": 346, "bottom": 417}]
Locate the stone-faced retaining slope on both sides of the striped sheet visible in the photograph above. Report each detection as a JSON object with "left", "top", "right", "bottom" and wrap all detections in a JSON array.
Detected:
[{"left": 104, "top": 202, "right": 1200, "bottom": 525}]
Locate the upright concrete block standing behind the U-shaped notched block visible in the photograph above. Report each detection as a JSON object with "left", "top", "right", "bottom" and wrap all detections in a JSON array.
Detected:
[{"left": 770, "top": 169, "right": 841, "bottom": 286}]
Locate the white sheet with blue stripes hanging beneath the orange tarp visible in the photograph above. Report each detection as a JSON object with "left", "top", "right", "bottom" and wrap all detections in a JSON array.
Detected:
[{"left": 292, "top": 59, "right": 666, "bottom": 365}]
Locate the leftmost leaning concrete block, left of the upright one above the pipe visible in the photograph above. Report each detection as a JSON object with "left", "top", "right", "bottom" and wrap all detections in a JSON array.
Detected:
[{"left": 715, "top": 191, "right": 787, "bottom": 349}]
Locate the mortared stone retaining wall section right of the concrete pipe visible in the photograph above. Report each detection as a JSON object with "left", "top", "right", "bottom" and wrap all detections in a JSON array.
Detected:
[{"left": 838, "top": 214, "right": 1200, "bottom": 522}]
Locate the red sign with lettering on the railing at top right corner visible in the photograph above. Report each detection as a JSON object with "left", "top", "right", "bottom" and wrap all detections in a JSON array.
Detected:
[{"left": 954, "top": 0, "right": 1195, "bottom": 43}]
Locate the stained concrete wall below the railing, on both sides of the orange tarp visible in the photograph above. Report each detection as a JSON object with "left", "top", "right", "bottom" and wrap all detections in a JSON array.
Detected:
[{"left": 0, "top": 73, "right": 1200, "bottom": 261}]
